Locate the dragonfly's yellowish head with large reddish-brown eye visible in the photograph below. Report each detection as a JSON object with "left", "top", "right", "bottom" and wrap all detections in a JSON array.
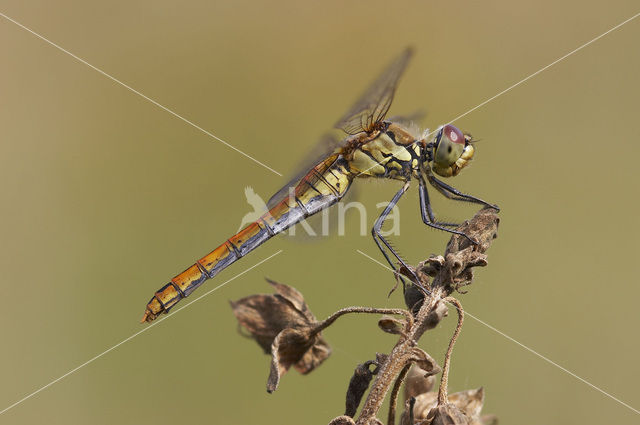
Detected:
[{"left": 431, "top": 124, "right": 474, "bottom": 177}]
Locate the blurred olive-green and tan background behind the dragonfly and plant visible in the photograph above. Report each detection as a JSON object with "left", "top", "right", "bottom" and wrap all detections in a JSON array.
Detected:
[{"left": 0, "top": 0, "right": 640, "bottom": 424}]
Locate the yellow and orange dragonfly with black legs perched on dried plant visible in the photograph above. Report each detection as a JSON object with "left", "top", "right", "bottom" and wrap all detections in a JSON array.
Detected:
[{"left": 142, "top": 48, "right": 498, "bottom": 323}]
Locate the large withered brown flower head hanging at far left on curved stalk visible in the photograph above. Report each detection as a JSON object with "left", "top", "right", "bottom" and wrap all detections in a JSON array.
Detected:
[{"left": 231, "top": 280, "right": 331, "bottom": 392}]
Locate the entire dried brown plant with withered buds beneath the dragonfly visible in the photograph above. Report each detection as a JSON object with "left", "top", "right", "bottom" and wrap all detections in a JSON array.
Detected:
[{"left": 236, "top": 207, "right": 499, "bottom": 425}]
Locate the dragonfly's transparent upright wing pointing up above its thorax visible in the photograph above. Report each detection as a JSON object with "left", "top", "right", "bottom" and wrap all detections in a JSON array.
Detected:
[{"left": 335, "top": 48, "right": 413, "bottom": 134}]
